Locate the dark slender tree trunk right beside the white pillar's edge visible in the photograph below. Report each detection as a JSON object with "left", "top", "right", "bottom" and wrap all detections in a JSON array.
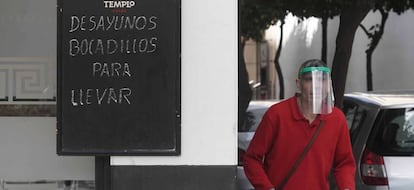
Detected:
[{"left": 238, "top": 41, "right": 252, "bottom": 128}]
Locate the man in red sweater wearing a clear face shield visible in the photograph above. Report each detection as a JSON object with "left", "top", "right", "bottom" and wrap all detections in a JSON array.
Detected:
[{"left": 243, "top": 60, "right": 355, "bottom": 190}]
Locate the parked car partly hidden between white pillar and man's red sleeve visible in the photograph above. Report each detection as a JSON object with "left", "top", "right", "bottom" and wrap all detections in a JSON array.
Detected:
[{"left": 237, "top": 100, "right": 277, "bottom": 190}]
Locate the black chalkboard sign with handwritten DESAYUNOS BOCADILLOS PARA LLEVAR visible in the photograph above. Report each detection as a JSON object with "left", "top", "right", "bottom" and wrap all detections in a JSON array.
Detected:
[{"left": 57, "top": 0, "right": 181, "bottom": 155}]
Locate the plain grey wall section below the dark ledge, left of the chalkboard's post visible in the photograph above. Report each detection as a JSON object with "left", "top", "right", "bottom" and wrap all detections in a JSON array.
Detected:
[{"left": 0, "top": 117, "right": 95, "bottom": 181}]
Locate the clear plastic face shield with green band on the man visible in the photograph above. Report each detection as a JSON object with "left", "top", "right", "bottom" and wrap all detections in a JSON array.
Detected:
[{"left": 299, "top": 67, "right": 334, "bottom": 114}]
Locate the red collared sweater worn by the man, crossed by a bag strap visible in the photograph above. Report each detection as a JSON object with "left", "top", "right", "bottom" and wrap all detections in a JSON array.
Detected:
[{"left": 243, "top": 96, "right": 355, "bottom": 190}]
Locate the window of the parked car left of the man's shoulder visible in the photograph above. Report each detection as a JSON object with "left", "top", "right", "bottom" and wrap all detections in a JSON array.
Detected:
[{"left": 239, "top": 107, "right": 267, "bottom": 132}]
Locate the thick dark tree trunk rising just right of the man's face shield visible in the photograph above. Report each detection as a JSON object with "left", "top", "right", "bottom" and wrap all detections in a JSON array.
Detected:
[{"left": 332, "top": 4, "right": 370, "bottom": 107}]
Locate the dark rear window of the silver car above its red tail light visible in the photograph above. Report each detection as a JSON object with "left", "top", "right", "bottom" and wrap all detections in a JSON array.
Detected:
[{"left": 373, "top": 108, "right": 414, "bottom": 156}]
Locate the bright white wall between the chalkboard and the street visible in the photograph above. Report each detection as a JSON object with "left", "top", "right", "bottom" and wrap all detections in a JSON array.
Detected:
[{"left": 111, "top": 0, "right": 238, "bottom": 165}]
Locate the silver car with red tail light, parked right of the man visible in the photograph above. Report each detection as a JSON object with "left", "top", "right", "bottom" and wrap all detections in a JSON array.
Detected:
[{"left": 342, "top": 91, "right": 414, "bottom": 190}]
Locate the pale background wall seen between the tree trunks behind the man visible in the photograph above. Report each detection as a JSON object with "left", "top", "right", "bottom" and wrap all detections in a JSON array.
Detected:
[{"left": 266, "top": 10, "right": 414, "bottom": 97}]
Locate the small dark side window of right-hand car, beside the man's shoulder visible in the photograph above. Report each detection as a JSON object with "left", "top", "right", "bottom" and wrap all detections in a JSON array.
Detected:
[{"left": 342, "top": 101, "right": 367, "bottom": 142}]
